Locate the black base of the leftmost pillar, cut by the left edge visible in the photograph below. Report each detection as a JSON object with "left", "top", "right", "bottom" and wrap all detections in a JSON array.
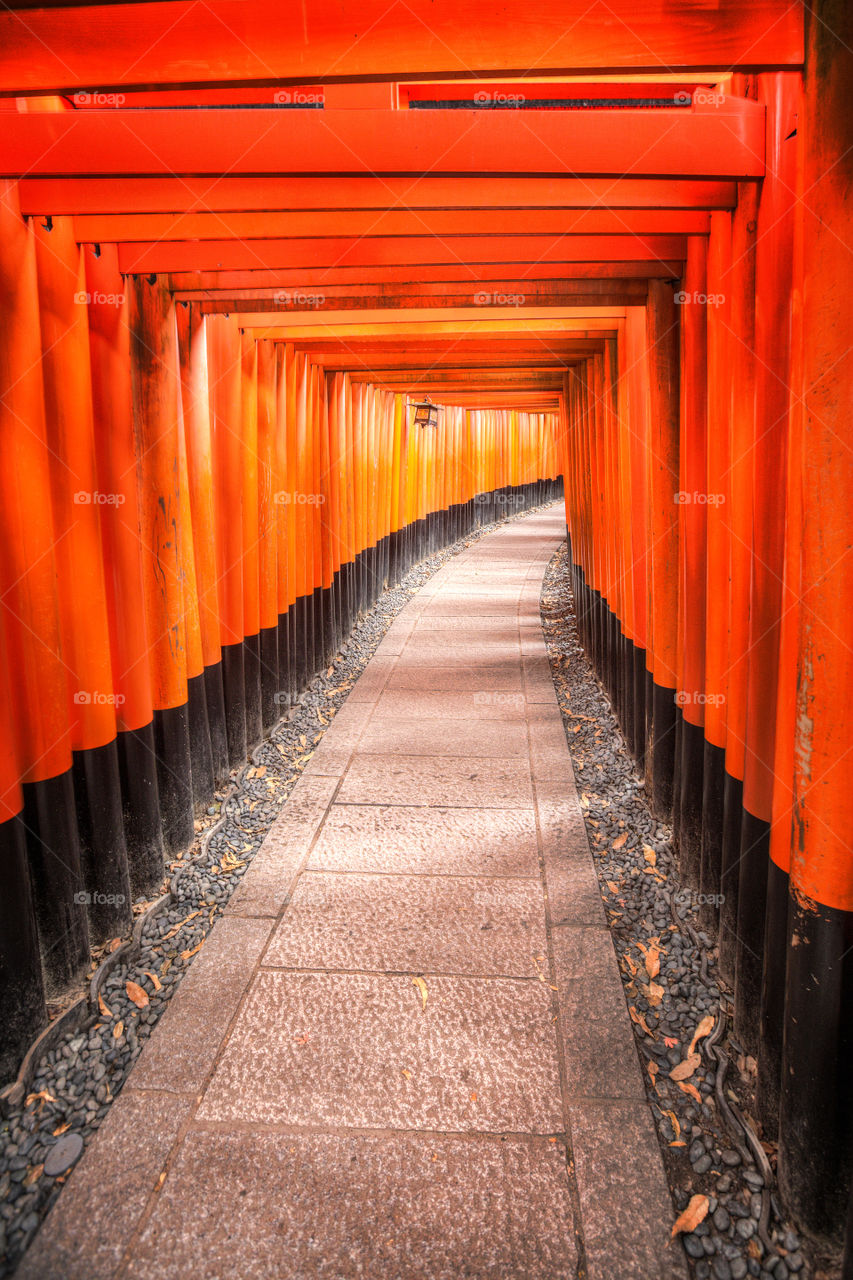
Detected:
[{"left": 0, "top": 817, "right": 47, "bottom": 1084}]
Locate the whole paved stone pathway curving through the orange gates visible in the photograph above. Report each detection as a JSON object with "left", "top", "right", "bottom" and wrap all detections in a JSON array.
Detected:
[{"left": 18, "top": 507, "right": 685, "bottom": 1280}]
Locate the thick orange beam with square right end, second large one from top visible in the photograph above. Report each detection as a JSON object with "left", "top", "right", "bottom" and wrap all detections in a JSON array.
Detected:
[{"left": 0, "top": 103, "right": 765, "bottom": 179}]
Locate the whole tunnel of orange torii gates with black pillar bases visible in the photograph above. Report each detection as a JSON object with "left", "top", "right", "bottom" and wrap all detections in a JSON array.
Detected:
[{"left": 0, "top": 0, "right": 853, "bottom": 1249}]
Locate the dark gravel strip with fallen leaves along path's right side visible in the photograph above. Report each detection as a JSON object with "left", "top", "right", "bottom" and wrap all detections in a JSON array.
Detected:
[{"left": 540, "top": 544, "right": 817, "bottom": 1280}]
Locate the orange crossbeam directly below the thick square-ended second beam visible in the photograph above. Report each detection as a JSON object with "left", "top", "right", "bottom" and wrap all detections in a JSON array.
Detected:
[{"left": 20, "top": 174, "right": 736, "bottom": 215}]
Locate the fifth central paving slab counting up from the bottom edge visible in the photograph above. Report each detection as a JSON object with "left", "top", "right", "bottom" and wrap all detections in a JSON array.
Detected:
[{"left": 337, "top": 753, "right": 533, "bottom": 809}]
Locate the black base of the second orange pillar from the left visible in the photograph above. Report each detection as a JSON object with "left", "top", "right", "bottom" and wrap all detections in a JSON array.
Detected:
[{"left": 23, "top": 769, "right": 88, "bottom": 996}]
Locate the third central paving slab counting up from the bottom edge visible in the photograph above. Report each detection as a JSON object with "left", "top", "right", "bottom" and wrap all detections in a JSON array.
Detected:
[{"left": 264, "top": 872, "right": 546, "bottom": 978}]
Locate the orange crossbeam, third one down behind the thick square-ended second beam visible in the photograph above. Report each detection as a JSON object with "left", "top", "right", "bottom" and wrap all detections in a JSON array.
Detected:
[{"left": 118, "top": 236, "right": 686, "bottom": 273}]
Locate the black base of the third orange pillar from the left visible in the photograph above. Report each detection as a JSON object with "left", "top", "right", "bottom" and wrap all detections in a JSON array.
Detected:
[{"left": 72, "top": 741, "right": 132, "bottom": 946}]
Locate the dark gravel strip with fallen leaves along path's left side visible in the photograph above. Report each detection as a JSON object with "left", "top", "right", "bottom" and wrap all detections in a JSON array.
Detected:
[{"left": 0, "top": 503, "right": 552, "bottom": 1277}]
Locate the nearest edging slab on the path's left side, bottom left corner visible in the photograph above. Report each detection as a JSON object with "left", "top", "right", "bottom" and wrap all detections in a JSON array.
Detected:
[{"left": 15, "top": 1089, "right": 191, "bottom": 1280}]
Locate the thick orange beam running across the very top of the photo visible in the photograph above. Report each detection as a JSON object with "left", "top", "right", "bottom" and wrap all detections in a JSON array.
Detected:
[{"left": 0, "top": 0, "right": 803, "bottom": 93}]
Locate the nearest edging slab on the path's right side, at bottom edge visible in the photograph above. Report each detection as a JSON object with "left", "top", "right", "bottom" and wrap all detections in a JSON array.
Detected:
[{"left": 569, "top": 1102, "right": 688, "bottom": 1280}]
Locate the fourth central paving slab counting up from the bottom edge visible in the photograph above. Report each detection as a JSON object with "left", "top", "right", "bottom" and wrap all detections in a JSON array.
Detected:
[{"left": 307, "top": 805, "right": 539, "bottom": 877}]
